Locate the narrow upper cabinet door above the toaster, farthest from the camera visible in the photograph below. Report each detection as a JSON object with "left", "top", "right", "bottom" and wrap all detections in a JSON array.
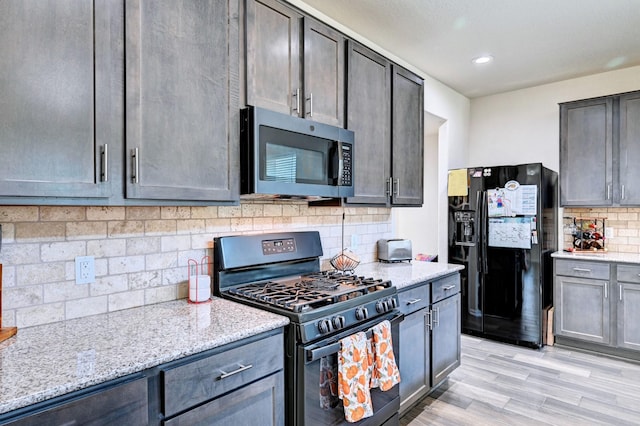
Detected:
[{"left": 391, "top": 65, "right": 424, "bottom": 206}]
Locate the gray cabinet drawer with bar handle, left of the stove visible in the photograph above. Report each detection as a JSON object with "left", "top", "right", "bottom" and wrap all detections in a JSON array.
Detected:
[{"left": 162, "top": 334, "right": 284, "bottom": 417}]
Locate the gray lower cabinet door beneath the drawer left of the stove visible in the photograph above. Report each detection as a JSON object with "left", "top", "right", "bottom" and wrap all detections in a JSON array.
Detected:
[{"left": 162, "top": 371, "right": 284, "bottom": 426}]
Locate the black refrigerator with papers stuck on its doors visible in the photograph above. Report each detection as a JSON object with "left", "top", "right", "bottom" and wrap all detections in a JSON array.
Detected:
[{"left": 448, "top": 163, "right": 558, "bottom": 348}]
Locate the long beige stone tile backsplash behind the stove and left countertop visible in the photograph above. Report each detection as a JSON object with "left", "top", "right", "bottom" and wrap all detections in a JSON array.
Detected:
[{"left": 0, "top": 201, "right": 392, "bottom": 328}]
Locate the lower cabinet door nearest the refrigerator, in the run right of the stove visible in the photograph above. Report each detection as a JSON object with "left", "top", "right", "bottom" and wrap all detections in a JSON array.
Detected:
[{"left": 431, "top": 293, "right": 462, "bottom": 387}]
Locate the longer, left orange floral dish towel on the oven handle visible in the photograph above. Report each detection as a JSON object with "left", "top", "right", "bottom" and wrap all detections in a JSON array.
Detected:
[{"left": 338, "top": 332, "right": 373, "bottom": 423}]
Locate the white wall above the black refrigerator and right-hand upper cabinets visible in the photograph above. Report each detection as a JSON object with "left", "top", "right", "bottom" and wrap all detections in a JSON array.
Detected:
[{"left": 464, "top": 67, "right": 640, "bottom": 171}]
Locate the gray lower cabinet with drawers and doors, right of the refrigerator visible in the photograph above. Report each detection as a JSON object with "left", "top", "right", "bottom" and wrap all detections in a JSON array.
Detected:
[{"left": 554, "top": 259, "right": 640, "bottom": 359}]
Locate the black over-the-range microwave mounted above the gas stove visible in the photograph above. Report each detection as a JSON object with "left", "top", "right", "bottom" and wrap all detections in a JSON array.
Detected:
[{"left": 240, "top": 107, "right": 354, "bottom": 199}]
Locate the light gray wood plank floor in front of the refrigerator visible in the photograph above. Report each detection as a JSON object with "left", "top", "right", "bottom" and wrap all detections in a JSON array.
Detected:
[{"left": 400, "top": 335, "right": 640, "bottom": 426}]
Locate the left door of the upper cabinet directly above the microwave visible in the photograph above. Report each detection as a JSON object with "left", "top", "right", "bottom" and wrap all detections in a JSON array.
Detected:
[{"left": 245, "top": 0, "right": 304, "bottom": 116}]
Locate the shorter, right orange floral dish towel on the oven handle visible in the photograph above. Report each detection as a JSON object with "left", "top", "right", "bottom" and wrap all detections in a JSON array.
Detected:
[{"left": 371, "top": 320, "right": 400, "bottom": 391}]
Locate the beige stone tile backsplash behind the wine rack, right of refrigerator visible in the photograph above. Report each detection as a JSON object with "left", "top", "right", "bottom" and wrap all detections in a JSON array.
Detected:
[{"left": 561, "top": 207, "right": 640, "bottom": 253}]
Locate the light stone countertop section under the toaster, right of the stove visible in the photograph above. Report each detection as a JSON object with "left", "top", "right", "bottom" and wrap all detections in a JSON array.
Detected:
[{"left": 354, "top": 260, "right": 464, "bottom": 290}]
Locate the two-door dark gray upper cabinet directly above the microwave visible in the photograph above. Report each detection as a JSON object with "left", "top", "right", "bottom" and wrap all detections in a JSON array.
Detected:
[{"left": 245, "top": 0, "right": 344, "bottom": 127}]
